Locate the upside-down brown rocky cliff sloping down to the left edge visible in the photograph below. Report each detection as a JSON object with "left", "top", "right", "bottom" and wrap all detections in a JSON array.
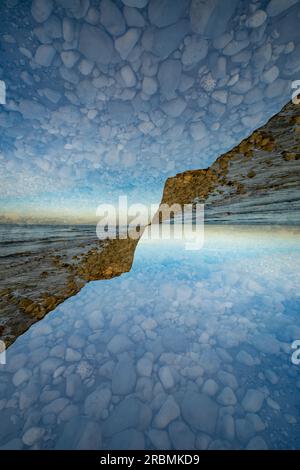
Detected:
[{"left": 0, "top": 233, "right": 141, "bottom": 346}]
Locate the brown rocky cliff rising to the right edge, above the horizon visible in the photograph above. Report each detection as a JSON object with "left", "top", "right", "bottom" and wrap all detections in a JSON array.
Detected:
[{"left": 162, "top": 102, "right": 300, "bottom": 224}]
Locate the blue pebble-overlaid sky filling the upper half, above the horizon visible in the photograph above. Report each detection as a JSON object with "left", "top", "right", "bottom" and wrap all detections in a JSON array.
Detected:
[{"left": 0, "top": 0, "right": 300, "bottom": 223}]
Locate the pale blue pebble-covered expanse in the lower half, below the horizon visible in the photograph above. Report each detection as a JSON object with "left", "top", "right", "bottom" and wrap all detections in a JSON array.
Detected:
[{"left": 0, "top": 227, "right": 300, "bottom": 449}]
